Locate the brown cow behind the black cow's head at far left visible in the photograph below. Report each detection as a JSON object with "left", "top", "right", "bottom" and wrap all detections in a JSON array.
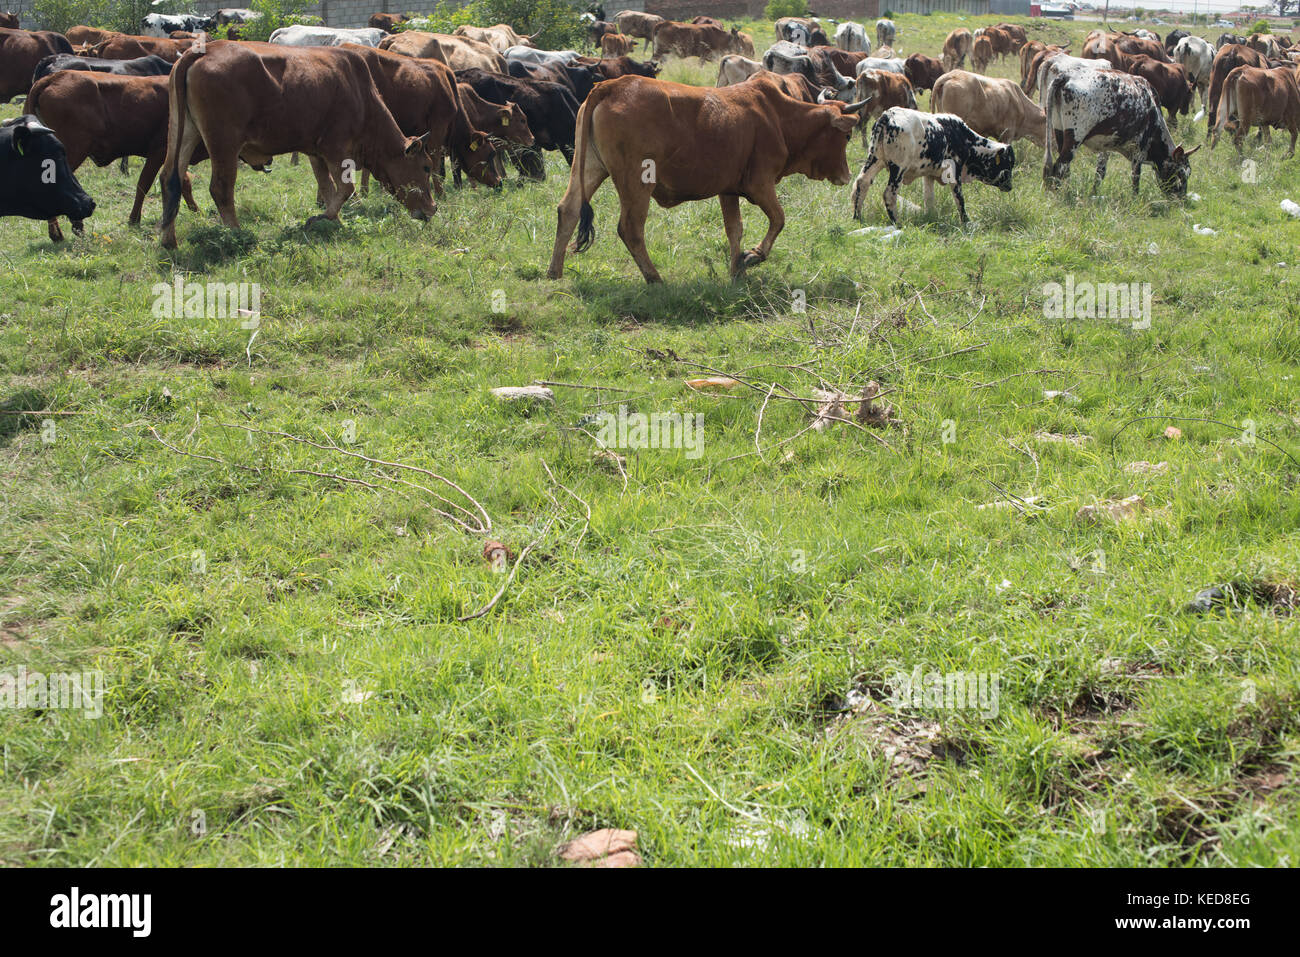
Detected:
[{"left": 26, "top": 70, "right": 208, "bottom": 242}]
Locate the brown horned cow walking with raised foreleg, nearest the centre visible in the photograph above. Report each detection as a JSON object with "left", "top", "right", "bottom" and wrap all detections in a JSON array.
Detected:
[{"left": 547, "top": 74, "right": 861, "bottom": 282}]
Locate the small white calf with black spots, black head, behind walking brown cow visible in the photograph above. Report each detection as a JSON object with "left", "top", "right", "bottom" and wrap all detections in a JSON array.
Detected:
[{"left": 853, "top": 107, "right": 1015, "bottom": 225}]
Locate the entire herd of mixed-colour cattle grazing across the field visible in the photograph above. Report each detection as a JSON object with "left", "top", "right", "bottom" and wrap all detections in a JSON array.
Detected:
[{"left": 0, "top": 9, "right": 1300, "bottom": 282}]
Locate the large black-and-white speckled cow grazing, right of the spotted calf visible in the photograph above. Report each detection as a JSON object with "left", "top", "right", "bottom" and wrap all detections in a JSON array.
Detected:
[{"left": 1043, "top": 70, "right": 1200, "bottom": 196}]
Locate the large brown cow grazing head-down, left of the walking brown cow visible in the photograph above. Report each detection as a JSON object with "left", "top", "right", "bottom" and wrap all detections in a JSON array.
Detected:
[{"left": 160, "top": 39, "right": 436, "bottom": 248}]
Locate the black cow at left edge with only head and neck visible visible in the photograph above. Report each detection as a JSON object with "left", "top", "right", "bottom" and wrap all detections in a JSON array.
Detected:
[{"left": 0, "top": 114, "right": 95, "bottom": 222}]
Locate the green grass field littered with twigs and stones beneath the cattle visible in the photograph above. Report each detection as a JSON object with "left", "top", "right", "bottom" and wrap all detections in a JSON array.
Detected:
[{"left": 0, "top": 16, "right": 1300, "bottom": 866}]
